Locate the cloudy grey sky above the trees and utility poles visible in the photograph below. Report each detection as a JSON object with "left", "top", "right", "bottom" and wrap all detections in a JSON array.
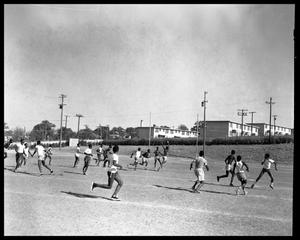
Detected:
[{"left": 4, "top": 4, "right": 295, "bottom": 131}]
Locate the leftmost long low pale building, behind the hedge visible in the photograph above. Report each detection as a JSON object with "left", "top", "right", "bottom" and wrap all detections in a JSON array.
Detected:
[{"left": 136, "top": 126, "right": 197, "bottom": 139}]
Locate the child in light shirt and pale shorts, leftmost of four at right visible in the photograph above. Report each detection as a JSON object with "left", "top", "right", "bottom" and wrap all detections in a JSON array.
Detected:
[{"left": 190, "top": 151, "right": 209, "bottom": 193}]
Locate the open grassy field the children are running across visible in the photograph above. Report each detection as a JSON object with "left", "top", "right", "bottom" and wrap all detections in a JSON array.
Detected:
[{"left": 4, "top": 144, "right": 293, "bottom": 236}]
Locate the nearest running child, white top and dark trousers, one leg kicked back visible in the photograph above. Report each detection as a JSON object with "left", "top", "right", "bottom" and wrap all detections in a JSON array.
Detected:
[{"left": 91, "top": 145, "right": 123, "bottom": 200}]
